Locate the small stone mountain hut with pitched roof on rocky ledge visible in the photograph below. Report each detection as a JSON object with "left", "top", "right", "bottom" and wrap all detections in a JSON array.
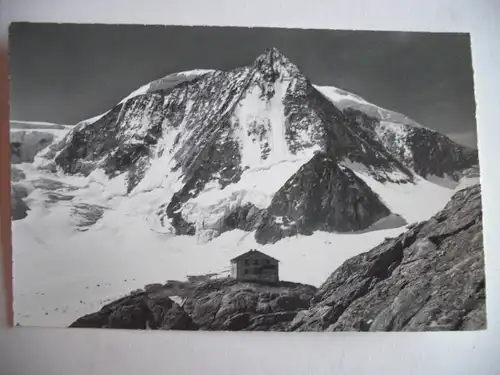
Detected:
[{"left": 231, "top": 250, "right": 279, "bottom": 283}]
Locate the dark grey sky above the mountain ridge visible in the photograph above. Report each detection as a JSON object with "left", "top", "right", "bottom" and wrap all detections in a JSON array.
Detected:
[{"left": 10, "top": 23, "right": 476, "bottom": 148}]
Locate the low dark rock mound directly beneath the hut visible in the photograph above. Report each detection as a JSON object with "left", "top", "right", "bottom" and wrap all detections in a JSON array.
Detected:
[{"left": 70, "top": 278, "right": 316, "bottom": 331}]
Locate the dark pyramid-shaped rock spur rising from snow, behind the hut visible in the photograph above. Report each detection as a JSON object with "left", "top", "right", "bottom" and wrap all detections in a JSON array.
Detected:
[{"left": 255, "top": 153, "right": 391, "bottom": 244}]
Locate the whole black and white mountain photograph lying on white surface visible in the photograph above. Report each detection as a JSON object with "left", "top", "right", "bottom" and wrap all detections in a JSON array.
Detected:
[{"left": 9, "top": 23, "right": 487, "bottom": 335}]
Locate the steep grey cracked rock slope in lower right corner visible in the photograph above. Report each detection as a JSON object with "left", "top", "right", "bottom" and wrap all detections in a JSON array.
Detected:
[{"left": 289, "top": 185, "right": 486, "bottom": 331}]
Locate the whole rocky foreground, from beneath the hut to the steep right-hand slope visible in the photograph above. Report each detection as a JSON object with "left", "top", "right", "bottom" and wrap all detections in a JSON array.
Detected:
[{"left": 71, "top": 185, "right": 486, "bottom": 331}]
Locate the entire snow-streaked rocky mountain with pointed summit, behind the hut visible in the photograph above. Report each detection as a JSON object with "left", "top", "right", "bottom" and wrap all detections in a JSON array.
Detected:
[{"left": 46, "top": 48, "right": 477, "bottom": 244}]
